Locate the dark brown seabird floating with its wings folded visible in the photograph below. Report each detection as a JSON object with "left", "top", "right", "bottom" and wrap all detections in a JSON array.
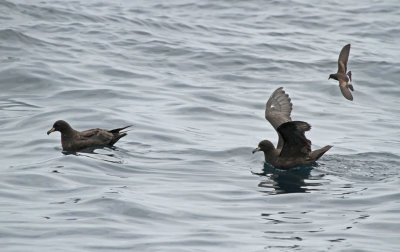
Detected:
[{"left": 47, "top": 120, "right": 130, "bottom": 151}]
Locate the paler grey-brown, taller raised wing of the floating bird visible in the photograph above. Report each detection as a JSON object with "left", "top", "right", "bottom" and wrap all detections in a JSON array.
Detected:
[{"left": 265, "top": 87, "right": 293, "bottom": 149}]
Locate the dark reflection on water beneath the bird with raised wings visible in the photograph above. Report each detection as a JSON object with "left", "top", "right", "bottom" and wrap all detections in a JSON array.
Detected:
[{"left": 253, "top": 163, "right": 321, "bottom": 194}]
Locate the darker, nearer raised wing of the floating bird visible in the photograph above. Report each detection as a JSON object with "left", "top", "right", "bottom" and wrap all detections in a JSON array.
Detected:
[{"left": 278, "top": 121, "right": 311, "bottom": 158}]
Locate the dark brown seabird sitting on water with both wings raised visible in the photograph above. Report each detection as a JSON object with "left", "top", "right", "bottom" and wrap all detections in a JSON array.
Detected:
[{"left": 253, "top": 87, "right": 332, "bottom": 169}]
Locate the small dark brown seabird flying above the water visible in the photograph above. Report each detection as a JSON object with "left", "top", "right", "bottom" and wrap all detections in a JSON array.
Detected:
[{"left": 328, "top": 44, "right": 354, "bottom": 101}]
